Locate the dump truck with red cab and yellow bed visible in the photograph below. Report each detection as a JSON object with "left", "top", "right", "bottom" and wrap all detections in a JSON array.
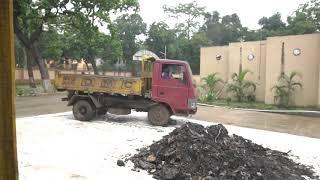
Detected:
[{"left": 55, "top": 58, "right": 197, "bottom": 126}]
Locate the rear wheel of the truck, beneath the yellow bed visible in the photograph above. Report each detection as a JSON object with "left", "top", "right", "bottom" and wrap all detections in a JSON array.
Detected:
[{"left": 72, "top": 100, "right": 95, "bottom": 121}]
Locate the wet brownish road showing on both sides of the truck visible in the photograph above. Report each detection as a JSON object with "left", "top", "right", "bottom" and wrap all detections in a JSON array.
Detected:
[{"left": 16, "top": 93, "right": 320, "bottom": 138}]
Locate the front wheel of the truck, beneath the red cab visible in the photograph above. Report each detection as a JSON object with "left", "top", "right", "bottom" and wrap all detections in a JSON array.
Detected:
[{"left": 148, "top": 104, "right": 171, "bottom": 126}]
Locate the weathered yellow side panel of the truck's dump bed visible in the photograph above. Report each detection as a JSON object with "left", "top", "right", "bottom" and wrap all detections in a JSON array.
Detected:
[{"left": 55, "top": 73, "right": 144, "bottom": 95}]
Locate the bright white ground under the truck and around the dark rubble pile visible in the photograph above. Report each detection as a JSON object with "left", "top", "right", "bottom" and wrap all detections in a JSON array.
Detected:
[{"left": 17, "top": 112, "right": 320, "bottom": 180}]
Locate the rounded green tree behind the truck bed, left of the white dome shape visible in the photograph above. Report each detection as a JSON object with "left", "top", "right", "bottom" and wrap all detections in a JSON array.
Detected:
[{"left": 114, "top": 13, "right": 147, "bottom": 61}]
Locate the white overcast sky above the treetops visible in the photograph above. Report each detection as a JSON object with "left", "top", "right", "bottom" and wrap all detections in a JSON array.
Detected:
[{"left": 139, "top": 0, "right": 307, "bottom": 29}]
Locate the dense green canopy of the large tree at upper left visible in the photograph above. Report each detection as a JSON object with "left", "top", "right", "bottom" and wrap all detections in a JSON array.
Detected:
[{"left": 14, "top": 0, "right": 138, "bottom": 73}]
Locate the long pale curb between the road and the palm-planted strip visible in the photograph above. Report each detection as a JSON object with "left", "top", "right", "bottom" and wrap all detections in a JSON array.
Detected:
[{"left": 197, "top": 103, "right": 320, "bottom": 117}]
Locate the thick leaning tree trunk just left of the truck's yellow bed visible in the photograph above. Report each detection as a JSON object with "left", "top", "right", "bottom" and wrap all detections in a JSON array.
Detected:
[{"left": 31, "top": 42, "right": 54, "bottom": 93}]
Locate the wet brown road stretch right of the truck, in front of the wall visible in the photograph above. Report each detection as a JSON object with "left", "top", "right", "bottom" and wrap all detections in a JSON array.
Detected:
[{"left": 193, "top": 106, "right": 320, "bottom": 138}]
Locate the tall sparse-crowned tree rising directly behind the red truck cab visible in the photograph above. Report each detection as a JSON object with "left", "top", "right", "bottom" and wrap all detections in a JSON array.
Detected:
[{"left": 162, "top": 1, "right": 209, "bottom": 74}]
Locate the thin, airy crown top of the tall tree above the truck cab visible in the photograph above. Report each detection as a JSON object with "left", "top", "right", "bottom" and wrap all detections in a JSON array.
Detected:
[{"left": 163, "top": 1, "right": 205, "bottom": 40}]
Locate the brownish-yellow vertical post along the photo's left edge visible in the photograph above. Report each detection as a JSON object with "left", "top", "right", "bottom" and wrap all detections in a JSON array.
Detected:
[{"left": 0, "top": 0, "right": 18, "bottom": 180}]
